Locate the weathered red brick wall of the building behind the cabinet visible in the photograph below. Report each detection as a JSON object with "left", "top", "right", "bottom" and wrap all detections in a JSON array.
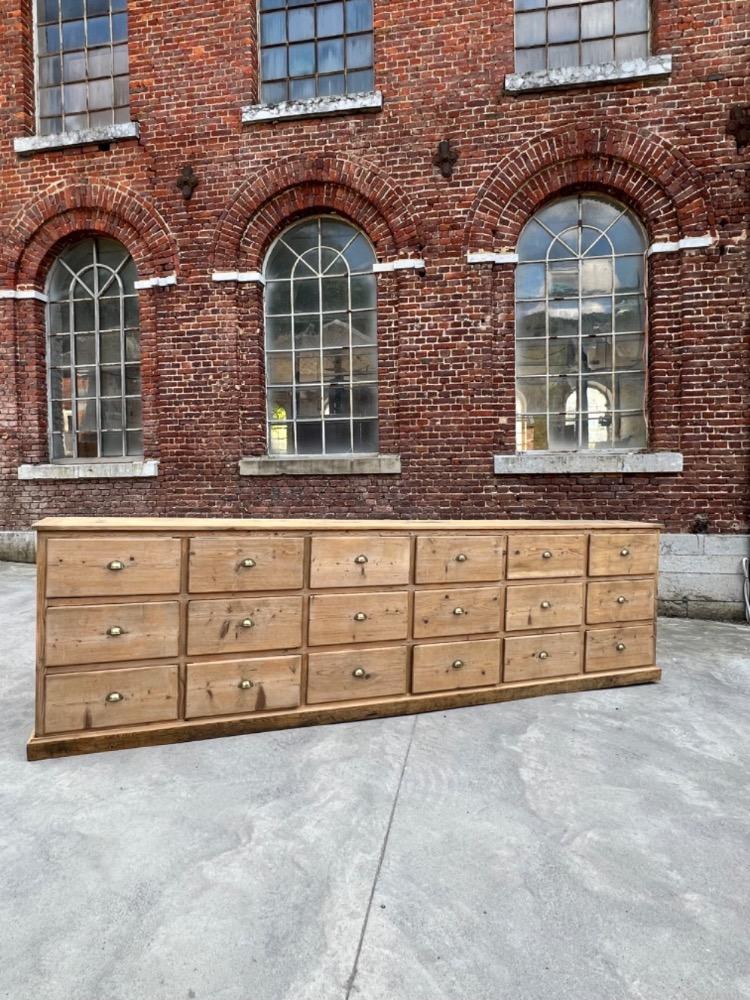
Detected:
[{"left": 0, "top": 0, "right": 750, "bottom": 531}]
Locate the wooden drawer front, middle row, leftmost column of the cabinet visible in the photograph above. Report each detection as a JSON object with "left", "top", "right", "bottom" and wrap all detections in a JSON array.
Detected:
[{"left": 45, "top": 601, "right": 180, "bottom": 667}]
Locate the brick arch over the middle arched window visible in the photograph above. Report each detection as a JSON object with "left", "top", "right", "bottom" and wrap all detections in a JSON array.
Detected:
[{"left": 212, "top": 156, "right": 423, "bottom": 271}]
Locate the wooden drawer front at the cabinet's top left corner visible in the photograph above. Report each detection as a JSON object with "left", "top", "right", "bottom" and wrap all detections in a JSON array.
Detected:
[{"left": 47, "top": 535, "right": 181, "bottom": 598}]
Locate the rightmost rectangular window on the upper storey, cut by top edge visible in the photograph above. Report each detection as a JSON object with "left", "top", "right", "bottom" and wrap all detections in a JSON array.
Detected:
[{"left": 515, "top": 0, "right": 650, "bottom": 73}]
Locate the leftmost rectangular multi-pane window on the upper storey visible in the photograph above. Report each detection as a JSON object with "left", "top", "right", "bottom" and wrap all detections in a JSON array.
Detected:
[{"left": 34, "top": 0, "right": 130, "bottom": 135}]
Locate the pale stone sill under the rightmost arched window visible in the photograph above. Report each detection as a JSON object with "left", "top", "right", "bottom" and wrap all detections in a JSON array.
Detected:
[{"left": 495, "top": 451, "right": 683, "bottom": 476}]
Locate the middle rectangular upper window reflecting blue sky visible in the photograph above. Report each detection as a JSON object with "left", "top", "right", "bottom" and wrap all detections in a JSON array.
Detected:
[{"left": 260, "top": 0, "right": 375, "bottom": 104}]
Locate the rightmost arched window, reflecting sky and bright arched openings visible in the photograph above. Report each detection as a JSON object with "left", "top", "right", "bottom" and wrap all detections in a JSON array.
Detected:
[{"left": 516, "top": 194, "right": 647, "bottom": 451}]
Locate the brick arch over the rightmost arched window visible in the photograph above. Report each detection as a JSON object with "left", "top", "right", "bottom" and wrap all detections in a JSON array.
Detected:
[{"left": 466, "top": 126, "right": 715, "bottom": 251}]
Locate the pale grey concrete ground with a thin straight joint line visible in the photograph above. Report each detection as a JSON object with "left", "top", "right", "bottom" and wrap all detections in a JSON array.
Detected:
[{"left": 0, "top": 563, "right": 750, "bottom": 1000}]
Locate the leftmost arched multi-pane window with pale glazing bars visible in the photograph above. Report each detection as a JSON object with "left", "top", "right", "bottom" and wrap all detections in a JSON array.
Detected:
[{"left": 47, "top": 238, "right": 143, "bottom": 461}]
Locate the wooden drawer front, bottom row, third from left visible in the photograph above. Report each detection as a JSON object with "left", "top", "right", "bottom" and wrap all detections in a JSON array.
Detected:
[{"left": 307, "top": 646, "right": 406, "bottom": 705}]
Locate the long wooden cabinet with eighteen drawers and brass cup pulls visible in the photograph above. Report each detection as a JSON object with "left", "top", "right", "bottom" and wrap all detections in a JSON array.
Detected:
[{"left": 28, "top": 518, "right": 660, "bottom": 758}]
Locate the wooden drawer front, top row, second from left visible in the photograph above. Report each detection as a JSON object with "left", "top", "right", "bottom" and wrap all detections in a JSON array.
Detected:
[{"left": 190, "top": 535, "right": 305, "bottom": 594}]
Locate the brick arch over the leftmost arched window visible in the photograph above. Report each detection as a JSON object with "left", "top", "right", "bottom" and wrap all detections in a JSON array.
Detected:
[{"left": 0, "top": 184, "right": 177, "bottom": 287}]
